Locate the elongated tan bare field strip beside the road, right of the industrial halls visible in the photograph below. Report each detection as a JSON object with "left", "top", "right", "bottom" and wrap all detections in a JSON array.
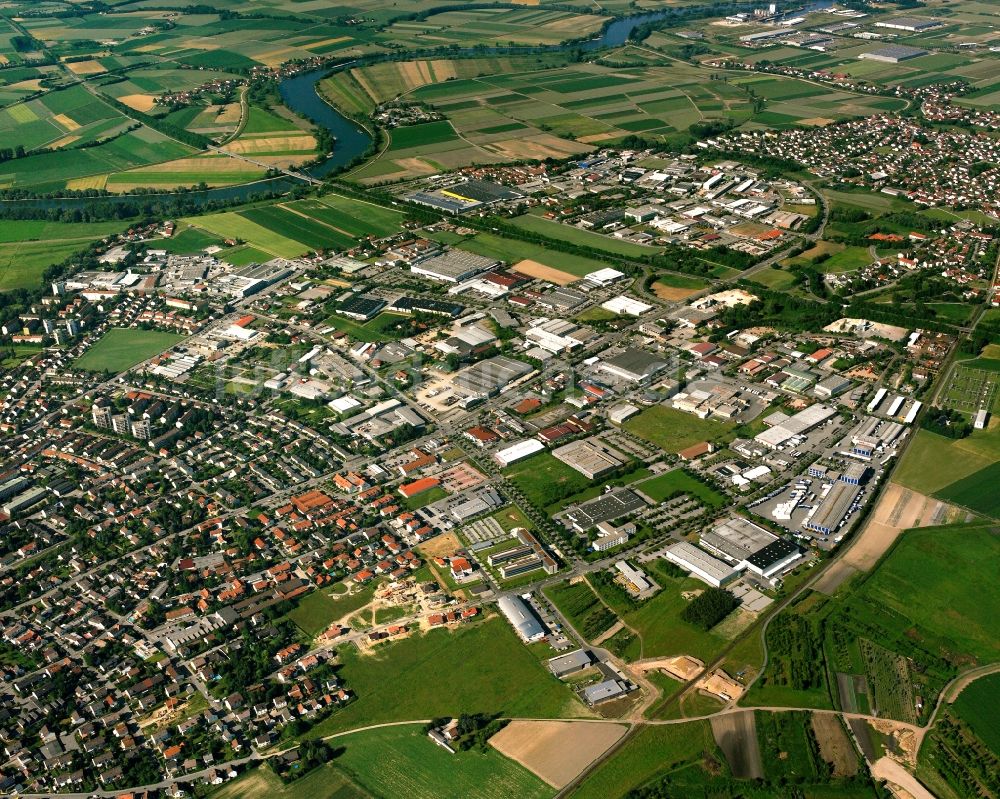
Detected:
[{"left": 816, "top": 483, "right": 939, "bottom": 594}]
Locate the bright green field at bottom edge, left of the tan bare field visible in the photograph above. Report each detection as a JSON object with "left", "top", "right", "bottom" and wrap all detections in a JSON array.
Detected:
[{"left": 334, "top": 725, "right": 555, "bottom": 799}]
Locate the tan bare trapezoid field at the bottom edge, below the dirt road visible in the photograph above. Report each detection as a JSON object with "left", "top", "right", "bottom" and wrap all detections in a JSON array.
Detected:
[{"left": 490, "top": 721, "right": 628, "bottom": 788}]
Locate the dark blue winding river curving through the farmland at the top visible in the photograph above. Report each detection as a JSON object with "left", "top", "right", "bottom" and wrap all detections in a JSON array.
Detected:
[{"left": 0, "top": 0, "right": 832, "bottom": 214}]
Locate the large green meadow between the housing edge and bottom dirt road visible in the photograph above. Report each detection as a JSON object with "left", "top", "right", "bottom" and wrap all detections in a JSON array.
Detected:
[{"left": 309, "top": 617, "right": 587, "bottom": 737}]
